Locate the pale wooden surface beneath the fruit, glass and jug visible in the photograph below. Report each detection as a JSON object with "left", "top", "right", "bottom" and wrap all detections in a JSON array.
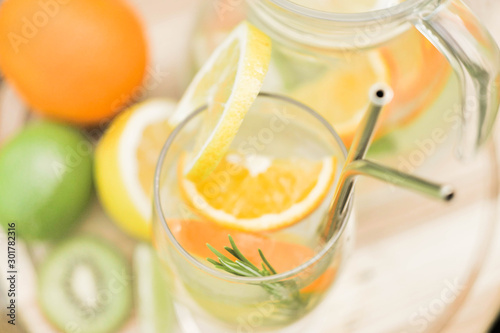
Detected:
[{"left": 0, "top": 0, "right": 500, "bottom": 333}]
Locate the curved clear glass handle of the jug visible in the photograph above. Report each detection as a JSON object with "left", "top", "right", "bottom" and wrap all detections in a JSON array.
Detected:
[{"left": 413, "top": 0, "right": 500, "bottom": 158}]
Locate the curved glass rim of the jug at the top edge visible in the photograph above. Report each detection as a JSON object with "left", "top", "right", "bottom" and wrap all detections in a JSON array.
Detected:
[{"left": 264, "top": 0, "right": 426, "bottom": 23}]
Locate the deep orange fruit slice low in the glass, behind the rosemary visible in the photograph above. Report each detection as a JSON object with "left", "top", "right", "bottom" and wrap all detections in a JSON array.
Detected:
[{"left": 167, "top": 219, "right": 337, "bottom": 293}]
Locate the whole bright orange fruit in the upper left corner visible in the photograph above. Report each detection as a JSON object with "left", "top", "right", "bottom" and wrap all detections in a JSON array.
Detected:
[{"left": 0, "top": 0, "right": 147, "bottom": 125}]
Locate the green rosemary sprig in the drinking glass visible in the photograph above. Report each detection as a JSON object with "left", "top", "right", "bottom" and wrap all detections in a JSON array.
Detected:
[{"left": 207, "top": 235, "right": 306, "bottom": 319}]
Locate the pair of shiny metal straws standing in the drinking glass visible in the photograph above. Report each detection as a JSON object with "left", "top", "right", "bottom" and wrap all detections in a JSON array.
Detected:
[{"left": 326, "top": 84, "right": 454, "bottom": 236}]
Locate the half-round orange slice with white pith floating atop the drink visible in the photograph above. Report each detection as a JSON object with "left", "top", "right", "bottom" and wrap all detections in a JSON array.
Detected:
[{"left": 179, "top": 153, "right": 336, "bottom": 232}]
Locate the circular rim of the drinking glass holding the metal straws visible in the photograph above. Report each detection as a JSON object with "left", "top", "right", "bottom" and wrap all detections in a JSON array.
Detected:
[{"left": 153, "top": 92, "right": 353, "bottom": 283}]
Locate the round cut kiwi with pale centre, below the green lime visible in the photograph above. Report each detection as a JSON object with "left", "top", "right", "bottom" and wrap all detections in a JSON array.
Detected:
[{"left": 38, "top": 236, "right": 132, "bottom": 333}]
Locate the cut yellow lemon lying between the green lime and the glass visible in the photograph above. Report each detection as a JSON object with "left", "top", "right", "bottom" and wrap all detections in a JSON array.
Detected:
[{"left": 95, "top": 99, "right": 176, "bottom": 240}]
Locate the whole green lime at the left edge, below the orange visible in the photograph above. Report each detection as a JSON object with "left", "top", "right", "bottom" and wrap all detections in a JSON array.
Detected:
[{"left": 0, "top": 121, "right": 92, "bottom": 240}]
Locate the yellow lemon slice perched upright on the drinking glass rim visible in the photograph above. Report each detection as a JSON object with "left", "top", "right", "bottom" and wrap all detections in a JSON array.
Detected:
[{"left": 170, "top": 22, "right": 271, "bottom": 181}]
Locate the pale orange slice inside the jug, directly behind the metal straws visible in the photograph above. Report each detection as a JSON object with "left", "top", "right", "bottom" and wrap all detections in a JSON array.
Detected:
[{"left": 291, "top": 52, "right": 389, "bottom": 144}]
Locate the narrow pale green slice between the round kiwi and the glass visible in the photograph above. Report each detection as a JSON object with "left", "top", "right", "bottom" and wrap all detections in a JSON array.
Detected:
[{"left": 134, "top": 244, "right": 175, "bottom": 333}]
